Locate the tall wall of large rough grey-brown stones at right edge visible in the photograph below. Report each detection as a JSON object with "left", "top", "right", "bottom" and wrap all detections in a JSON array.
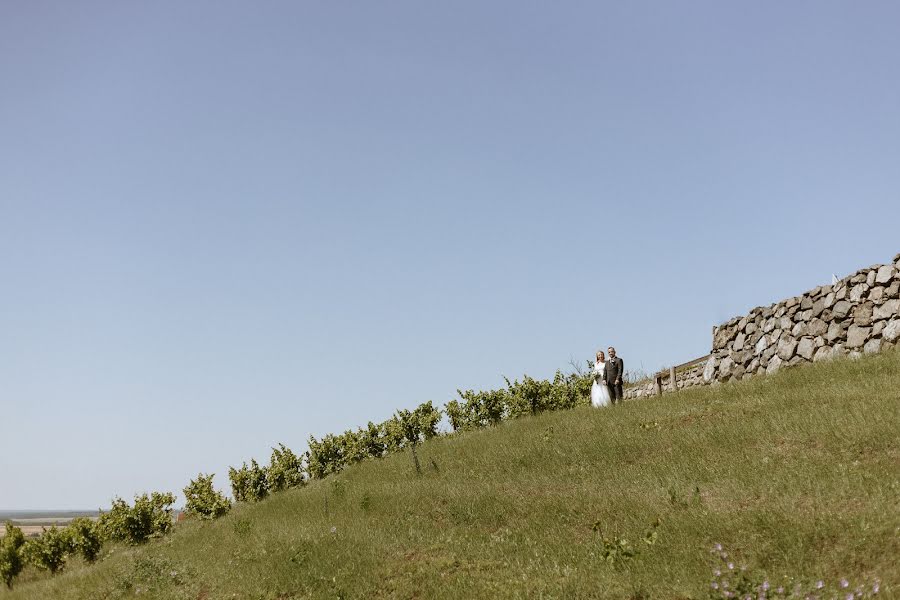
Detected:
[{"left": 703, "top": 254, "right": 900, "bottom": 383}]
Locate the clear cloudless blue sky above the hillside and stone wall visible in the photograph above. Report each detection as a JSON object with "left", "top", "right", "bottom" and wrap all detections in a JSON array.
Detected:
[{"left": 0, "top": 0, "right": 900, "bottom": 509}]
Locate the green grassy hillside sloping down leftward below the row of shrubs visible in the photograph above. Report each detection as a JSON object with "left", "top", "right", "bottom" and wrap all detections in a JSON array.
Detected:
[{"left": 0, "top": 352, "right": 900, "bottom": 600}]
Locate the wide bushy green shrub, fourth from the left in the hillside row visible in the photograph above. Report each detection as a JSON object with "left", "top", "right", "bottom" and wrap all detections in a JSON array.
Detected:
[{"left": 100, "top": 492, "right": 175, "bottom": 544}]
